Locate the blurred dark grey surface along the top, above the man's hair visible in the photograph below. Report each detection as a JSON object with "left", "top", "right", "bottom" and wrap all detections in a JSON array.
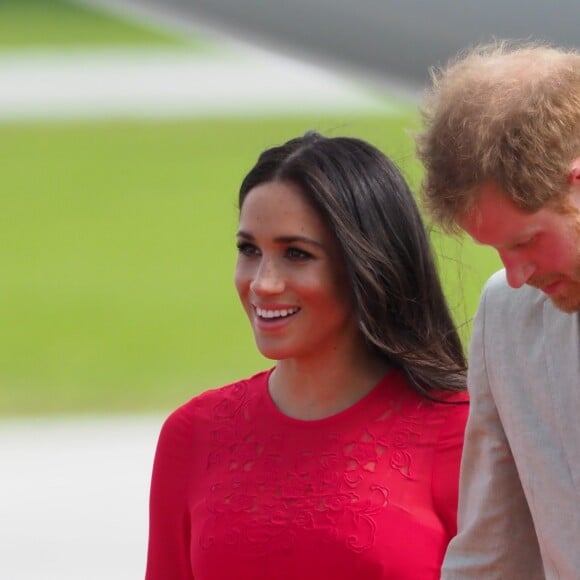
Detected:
[{"left": 82, "top": 0, "right": 580, "bottom": 87}]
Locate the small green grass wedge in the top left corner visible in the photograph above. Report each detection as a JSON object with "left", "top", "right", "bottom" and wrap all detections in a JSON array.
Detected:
[{"left": 0, "top": 0, "right": 208, "bottom": 51}]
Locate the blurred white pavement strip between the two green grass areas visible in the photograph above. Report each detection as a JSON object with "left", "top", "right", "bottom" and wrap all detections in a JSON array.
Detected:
[{"left": 0, "top": 51, "right": 398, "bottom": 119}]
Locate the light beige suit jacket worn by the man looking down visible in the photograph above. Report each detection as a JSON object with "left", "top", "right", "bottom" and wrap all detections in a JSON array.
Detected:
[{"left": 442, "top": 270, "right": 580, "bottom": 580}]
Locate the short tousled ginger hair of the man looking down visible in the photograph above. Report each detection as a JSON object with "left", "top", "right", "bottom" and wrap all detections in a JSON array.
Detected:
[{"left": 417, "top": 41, "right": 580, "bottom": 231}]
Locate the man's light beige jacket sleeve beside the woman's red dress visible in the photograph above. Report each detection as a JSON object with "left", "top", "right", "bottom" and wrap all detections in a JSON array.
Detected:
[{"left": 442, "top": 284, "right": 544, "bottom": 580}]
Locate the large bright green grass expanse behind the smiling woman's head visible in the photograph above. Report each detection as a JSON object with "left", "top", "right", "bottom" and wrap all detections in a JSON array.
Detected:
[{"left": 0, "top": 115, "right": 498, "bottom": 415}]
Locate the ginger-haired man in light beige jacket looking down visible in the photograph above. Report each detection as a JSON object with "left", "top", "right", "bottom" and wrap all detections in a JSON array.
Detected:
[{"left": 418, "top": 43, "right": 580, "bottom": 580}]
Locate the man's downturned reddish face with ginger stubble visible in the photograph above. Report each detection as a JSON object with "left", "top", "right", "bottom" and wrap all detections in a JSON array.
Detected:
[{"left": 459, "top": 183, "right": 580, "bottom": 312}]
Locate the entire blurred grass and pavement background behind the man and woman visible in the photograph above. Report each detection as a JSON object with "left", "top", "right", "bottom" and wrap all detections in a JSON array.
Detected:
[{"left": 0, "top": 0, "right": 577, "bottom": 580}]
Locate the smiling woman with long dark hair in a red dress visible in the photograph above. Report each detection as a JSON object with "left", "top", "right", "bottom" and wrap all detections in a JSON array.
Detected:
[{"left": 147, "top": 133, "right": 467, "bottom": 580}]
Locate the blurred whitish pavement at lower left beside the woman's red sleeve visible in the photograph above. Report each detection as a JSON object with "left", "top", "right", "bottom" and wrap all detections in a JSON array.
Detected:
[{"left": 0, "top": 416, "right": 163, "bottom": 580}]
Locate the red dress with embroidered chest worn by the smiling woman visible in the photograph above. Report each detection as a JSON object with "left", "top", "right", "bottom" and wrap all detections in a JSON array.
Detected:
[{"left": 146, "top": 371, "right": 468, "bottom": 580}]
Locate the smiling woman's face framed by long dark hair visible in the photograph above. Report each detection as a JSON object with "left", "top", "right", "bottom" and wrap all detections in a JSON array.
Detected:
[{"left": 235, "top": 182, "right": 360, "bottom": 360}]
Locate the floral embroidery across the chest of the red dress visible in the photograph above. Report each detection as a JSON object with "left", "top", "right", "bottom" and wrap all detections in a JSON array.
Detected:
[{"left": 200, "top": 383, "right": 428, "bottom": 557}]
